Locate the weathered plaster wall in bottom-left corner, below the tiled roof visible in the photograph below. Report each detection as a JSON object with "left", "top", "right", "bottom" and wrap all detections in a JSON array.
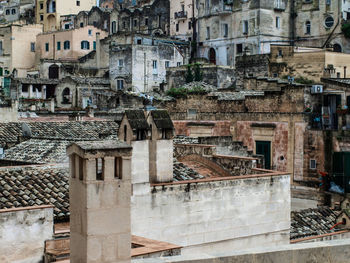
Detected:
[{"left": 0, "top": 206, "right": 53, "bottom": 263}]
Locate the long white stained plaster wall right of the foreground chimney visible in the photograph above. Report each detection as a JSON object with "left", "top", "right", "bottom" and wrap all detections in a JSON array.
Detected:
[{"left": 131, "top": 175, "right": 290, "bottom": 253}]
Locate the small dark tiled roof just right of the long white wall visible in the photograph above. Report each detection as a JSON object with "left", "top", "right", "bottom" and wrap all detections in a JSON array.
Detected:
[{"left": 290, "top": 207, "right": 339, "bottom": 239}]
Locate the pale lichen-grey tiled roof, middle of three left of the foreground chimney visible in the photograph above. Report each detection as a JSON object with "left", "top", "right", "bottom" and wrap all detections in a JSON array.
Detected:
[{"left": 2, "top": 139, "right": 71, "bottom": 164}]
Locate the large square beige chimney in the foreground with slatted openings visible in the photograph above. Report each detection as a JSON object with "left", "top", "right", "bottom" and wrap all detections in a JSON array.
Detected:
[{"left": 67, "top": 140, "right": 132, "bottom": 263}]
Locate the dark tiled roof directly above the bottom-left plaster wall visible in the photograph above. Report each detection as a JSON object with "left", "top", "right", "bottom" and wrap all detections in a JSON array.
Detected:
[{"left": 0, "top": 166, "right": 69, "bottom": 220}]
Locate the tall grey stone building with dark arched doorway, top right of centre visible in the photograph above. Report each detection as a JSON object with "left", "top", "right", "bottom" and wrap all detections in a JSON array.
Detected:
[{"left": 197, "top": 0, "right": 291, "bottom": 66}]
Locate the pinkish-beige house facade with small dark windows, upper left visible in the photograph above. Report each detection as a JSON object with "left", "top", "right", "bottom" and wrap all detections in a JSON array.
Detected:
[{"left": 37, "top": 26, "right": 108, "bottom": 60}]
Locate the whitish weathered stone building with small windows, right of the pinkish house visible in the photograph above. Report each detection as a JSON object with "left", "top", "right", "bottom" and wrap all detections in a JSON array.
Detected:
[{"left": 109, "top": 33, "right": 188, "bottom": 92}]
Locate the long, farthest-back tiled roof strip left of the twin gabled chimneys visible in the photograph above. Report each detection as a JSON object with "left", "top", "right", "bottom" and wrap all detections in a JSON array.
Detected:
[{"left": 0, "top": 121, "right": 118, "bottom": 145}]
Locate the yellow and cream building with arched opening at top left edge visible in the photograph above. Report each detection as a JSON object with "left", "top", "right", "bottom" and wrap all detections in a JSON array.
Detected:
[{"left": 35, "top": 0, "right": 96, "bottom": 32}]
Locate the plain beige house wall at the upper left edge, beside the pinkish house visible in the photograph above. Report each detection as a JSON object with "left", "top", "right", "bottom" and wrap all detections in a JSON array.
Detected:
[{"left": 0, "top": 25, "right": 42, "bottom": 77}]
